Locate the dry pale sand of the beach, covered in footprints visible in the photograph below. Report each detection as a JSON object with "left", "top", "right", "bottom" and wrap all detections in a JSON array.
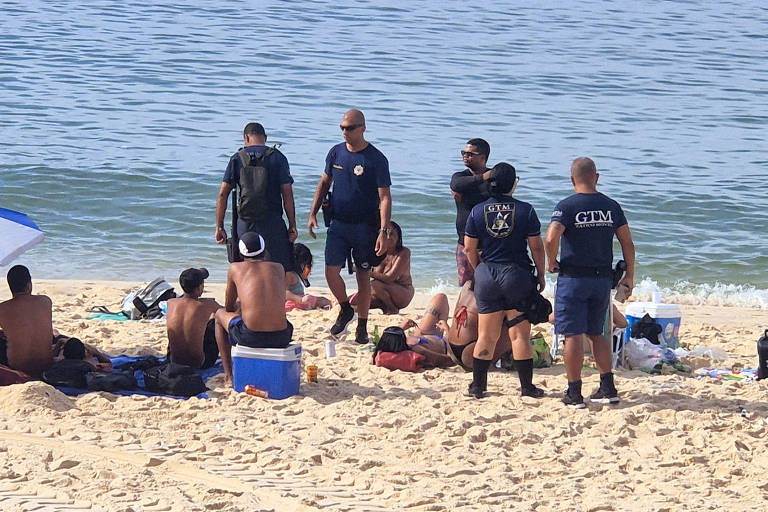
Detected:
[{"left": 0, "top": 281, "right": 768, "bottom": 512}]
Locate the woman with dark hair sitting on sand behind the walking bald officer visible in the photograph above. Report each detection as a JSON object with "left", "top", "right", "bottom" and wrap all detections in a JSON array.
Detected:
[{"left": 349, "top": 222, "right": 414, "bottom": 315}]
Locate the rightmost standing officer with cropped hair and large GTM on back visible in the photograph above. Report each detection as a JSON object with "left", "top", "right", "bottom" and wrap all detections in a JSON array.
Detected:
[{"left": 545, "top": 157, "right": 635, "bottom": 409}]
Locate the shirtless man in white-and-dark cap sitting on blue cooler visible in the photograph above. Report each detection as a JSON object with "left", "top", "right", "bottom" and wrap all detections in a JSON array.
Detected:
[{"left": 216, "top": 231, "right": 293, "bottom": 386}]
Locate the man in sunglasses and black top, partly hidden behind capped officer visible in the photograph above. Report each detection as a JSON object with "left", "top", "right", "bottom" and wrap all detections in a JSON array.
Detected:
[{"left": 451, "top": 139, "right": 491, "bottom": 286}]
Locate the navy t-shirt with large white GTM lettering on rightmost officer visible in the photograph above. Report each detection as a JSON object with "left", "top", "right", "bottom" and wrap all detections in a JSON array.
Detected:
[{"left": 552, "top": 192, "right": 627, "bottom": 268}]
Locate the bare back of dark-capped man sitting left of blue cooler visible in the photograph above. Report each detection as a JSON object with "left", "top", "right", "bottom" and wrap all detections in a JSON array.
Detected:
[{"left": 166, "top": 295, "right": 221, "bottom": 368}]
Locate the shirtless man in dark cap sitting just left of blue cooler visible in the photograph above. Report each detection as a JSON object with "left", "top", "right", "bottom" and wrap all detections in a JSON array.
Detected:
[{"left": 166, "top": 268, "right": 221, "bottom": 368}]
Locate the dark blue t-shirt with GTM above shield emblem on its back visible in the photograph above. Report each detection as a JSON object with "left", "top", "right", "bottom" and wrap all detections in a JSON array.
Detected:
[{"left": 464, "top": 197, "right": 541, "bottom": 268}]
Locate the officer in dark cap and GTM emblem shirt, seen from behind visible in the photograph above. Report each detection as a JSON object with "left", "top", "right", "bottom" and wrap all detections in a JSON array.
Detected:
[{"left": 464, "top": 162, "right": 545, "bottom": 398}]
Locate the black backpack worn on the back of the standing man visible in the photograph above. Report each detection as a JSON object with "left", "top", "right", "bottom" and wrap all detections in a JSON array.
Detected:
[{"left": 237, "top": 147, "right": 277, "bottom": 222}]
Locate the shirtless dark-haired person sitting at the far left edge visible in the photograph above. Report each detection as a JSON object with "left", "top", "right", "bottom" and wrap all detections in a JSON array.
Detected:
[{"left": 0, "top": 265, "right": 53, "bottom": 379}]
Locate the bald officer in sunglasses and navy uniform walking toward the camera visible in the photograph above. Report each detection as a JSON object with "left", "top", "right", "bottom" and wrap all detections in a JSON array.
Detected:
[{"left": 307, "top": 109, "right": 394, "bottom": 344}]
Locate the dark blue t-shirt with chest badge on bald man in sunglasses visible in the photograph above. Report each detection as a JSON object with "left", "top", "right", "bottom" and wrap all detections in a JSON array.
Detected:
[{"left": 325, "top": 142, "right": 392, "bottom": 222}]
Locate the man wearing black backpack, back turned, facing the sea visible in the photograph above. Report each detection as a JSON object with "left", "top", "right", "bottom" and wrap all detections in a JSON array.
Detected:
[{"left": 215, "top": 123, "right": 297, "bottom": 272}]
